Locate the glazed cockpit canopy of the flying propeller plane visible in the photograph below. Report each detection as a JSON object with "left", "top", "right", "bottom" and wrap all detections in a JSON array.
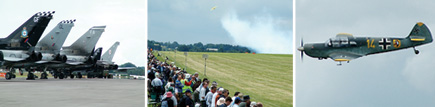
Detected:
[{"left": 325, "top": 33, "right": 357, "bottom": 47}]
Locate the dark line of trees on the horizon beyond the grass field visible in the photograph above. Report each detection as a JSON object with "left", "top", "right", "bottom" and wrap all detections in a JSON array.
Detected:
[{"left": 148, "top": 40, "right": 252, "bottom": 53}]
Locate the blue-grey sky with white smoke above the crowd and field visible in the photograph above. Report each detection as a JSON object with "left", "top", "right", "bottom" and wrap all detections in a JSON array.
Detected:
[{"left": 148, "top": 0, "right": 293, "bottom": 54}]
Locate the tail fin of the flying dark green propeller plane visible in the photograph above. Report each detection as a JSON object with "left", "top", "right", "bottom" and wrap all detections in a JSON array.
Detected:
[{"left": 406, "top": 22, "right": 432, "bottom": 44}]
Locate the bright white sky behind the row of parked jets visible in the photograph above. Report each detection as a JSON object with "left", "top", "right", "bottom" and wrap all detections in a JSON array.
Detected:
[{"left": 0, "top": 0, "right": 146, "bottom": 66}]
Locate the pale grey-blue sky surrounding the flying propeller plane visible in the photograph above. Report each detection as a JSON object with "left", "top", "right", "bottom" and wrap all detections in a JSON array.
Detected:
[{"left": 295, "top": 0, "right": 435, "bottom": 107}]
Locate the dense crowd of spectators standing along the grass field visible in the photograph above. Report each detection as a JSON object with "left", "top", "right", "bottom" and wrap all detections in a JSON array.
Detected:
[{"left": 147, "top": 50, "right": 263, "bottom": 107}]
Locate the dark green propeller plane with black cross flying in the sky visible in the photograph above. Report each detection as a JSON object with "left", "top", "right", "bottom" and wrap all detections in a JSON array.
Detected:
[{"left": 298, "top": 22, "right": 432, "bottom": 65}]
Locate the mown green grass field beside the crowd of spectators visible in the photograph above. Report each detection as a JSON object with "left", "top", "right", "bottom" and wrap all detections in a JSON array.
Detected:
[{"left": 153, "top": 51, "right": 293, "bottom": 107}]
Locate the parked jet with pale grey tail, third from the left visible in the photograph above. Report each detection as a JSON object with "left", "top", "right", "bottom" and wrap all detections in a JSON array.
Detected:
[{"left": 46, "top": 26, "right": 106, "bottom": 79}]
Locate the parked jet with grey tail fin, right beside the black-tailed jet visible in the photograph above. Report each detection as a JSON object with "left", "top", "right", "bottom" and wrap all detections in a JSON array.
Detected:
[{"left": 7, "top": 20, "right": 75, "bottom": 80}]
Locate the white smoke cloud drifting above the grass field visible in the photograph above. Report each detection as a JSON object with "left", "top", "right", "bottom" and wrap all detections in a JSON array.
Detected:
[{"left": 221, "top": 12, "right": 293, "bottom": 54}]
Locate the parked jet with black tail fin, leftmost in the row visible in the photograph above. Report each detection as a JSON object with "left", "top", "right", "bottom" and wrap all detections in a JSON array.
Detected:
[{"left": 0, "top": 11, "right": 54, "bottom": 79}]
